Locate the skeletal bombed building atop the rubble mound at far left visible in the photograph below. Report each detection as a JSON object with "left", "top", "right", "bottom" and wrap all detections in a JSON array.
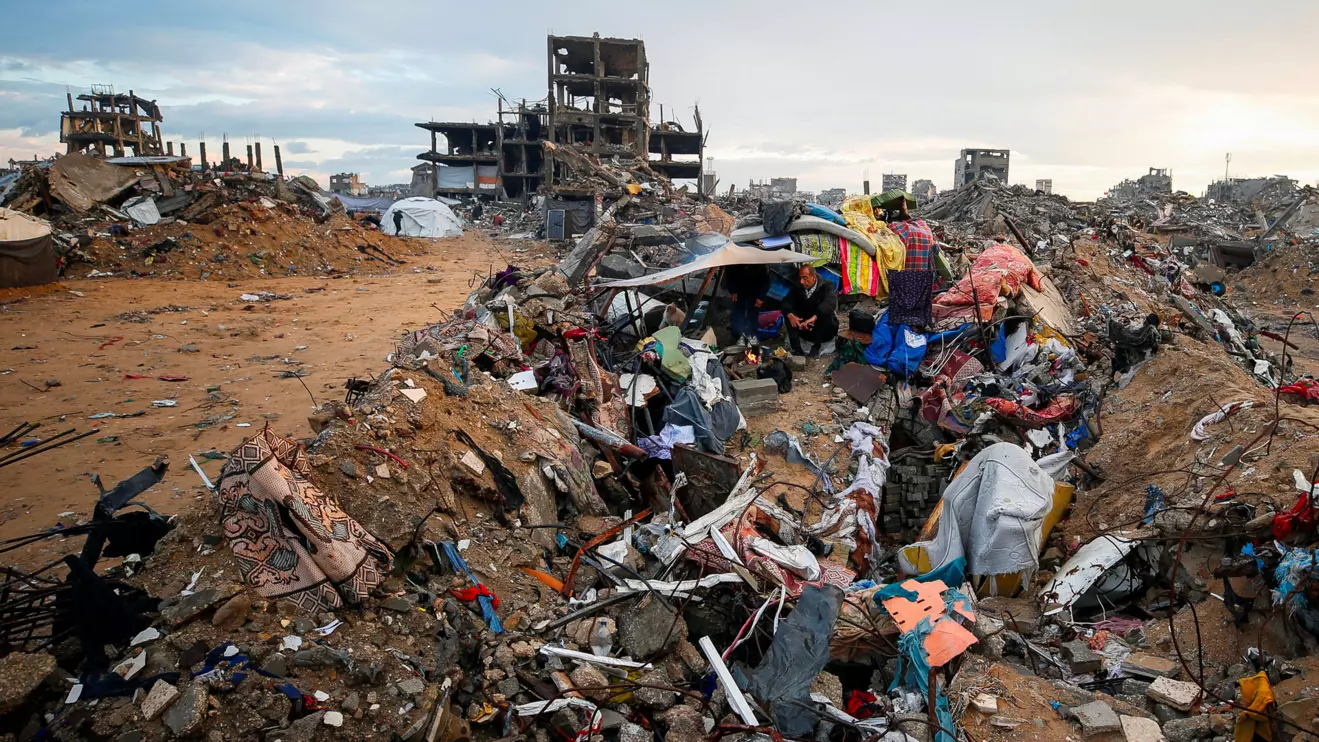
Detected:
[{"left": 59, "top": 86, "right": 164, "bottom": 157}]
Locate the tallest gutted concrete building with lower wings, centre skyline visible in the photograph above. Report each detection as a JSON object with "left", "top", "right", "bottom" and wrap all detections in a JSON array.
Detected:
[{"left": 417, "top": 34, "right": 706, "bottom": 222}]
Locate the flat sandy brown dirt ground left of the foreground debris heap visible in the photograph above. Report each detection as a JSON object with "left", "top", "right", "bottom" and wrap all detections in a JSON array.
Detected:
[{"left": 0, "top": 233, "right": 551, "bottom": 566}]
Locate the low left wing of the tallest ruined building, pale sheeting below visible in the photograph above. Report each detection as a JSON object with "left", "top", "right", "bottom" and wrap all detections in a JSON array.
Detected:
[{"left": 417, "top": 121, "right": 500, "bottom": 198}]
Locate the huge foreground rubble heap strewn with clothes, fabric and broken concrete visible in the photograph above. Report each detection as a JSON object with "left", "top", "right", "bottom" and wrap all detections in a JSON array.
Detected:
[{"left": 0, "top": 164, "right": 1319, "bottom": 742}]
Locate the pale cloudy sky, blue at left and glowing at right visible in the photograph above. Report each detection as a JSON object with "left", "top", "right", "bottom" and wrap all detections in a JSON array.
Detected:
[{"left": 0, "top": 0, "right": 1319, "bottom": 199}]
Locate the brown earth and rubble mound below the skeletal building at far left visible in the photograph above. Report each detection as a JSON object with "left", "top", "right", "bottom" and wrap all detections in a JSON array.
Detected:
[{"left": 0, "top": 154, "right": 440, "bottom": 279}]
